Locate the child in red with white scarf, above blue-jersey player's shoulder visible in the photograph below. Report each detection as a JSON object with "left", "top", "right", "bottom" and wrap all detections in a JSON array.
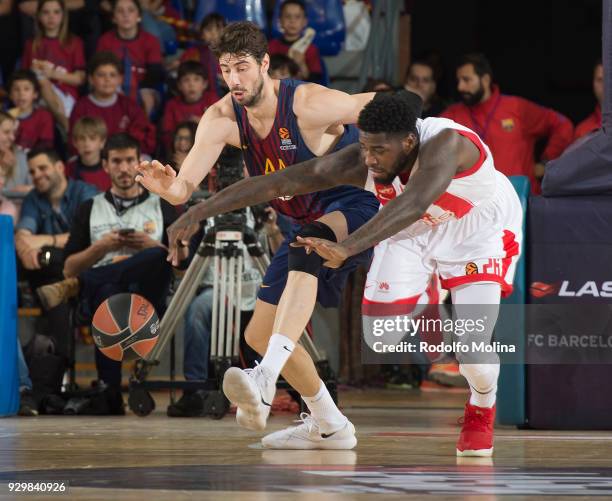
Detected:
[{"left": 268, "top": 0, "right": 323, "bottom": 83}]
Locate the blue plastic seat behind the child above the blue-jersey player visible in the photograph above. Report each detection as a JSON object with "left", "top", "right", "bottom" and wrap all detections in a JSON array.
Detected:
[{"left": 270, "top": 0, "right": 346, "bottom": 56}]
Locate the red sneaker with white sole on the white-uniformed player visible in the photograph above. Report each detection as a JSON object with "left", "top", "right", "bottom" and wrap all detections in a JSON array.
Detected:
[{"left": 457, "top": 401, "right": 495, "bottom": 457}]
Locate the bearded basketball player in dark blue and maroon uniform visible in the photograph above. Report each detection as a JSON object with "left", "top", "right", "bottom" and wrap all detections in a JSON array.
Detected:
[{"left": 137, "top": 22, "right": 394, "bottom": 449}]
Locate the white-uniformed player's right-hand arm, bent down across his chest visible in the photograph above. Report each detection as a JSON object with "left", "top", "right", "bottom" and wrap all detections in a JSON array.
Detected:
[{"left": 304, "top": 129, "right": 479, "bottom": 261}]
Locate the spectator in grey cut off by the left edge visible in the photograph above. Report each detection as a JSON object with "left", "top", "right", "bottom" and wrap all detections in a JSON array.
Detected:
[{"left": 0, "top": 111, "right": 32, "bottom": 193}]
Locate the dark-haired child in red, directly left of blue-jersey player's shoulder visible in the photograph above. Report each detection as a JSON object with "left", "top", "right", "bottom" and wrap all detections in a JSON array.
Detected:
[{"left": 162, "top": 61, "right": 219, "bottom": 148}]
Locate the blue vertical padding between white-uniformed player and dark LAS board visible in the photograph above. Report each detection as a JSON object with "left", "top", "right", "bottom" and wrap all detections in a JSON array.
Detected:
[{"left": 495, "top": 176, "right": 530, "bottom": 425}]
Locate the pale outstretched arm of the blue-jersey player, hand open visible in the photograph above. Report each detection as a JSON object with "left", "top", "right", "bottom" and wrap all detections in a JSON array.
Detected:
[{"left": 136, "top": 106, "right": 236, "bottom": 205}]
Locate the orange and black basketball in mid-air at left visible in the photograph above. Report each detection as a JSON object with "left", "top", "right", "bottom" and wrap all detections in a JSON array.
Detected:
[{"left": 91, "top": 293, "right": 159, "bottom": 361}]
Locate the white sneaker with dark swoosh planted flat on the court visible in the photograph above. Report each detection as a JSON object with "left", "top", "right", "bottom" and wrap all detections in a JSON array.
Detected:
[{"left": 261, "top": 412, "right": 357, "bottom": 449}]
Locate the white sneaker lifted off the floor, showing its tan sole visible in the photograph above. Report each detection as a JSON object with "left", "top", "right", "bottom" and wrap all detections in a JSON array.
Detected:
[{"left": 223, "top": 365, "right": 276, "bottom": 431}]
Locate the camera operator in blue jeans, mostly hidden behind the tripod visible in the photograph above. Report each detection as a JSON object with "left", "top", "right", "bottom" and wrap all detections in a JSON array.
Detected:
[{"left": 168, "top": 147, "right": 285, "bottom": 417}]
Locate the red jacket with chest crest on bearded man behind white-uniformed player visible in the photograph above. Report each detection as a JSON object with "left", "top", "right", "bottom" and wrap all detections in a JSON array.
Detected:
[{"left": 440, "top": 86, "right": 574, "bottom": 193}]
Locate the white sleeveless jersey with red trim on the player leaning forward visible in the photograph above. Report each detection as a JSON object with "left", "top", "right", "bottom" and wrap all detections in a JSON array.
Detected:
[{"left": 365, "top": 118, "right": 498, "bottom": 234}]
